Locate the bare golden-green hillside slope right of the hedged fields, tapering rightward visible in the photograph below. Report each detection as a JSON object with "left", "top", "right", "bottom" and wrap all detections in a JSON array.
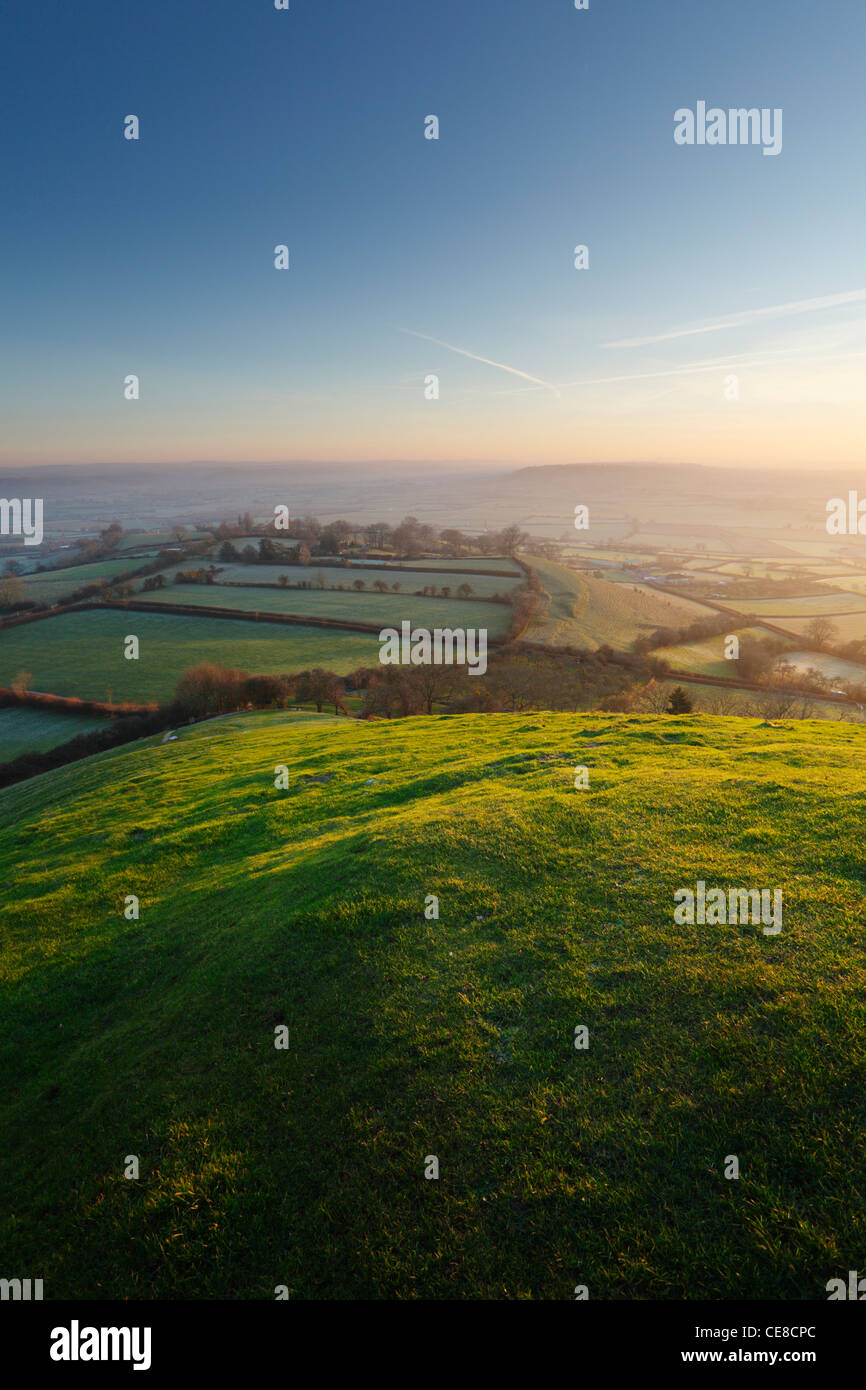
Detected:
[{"left": 527, "top": 556, "right": 712, "bottom": 651}]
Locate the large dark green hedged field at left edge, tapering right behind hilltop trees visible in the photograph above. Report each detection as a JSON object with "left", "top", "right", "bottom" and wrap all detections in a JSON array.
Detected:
[{"left": 0, "top": 611, "right": 383, "bottom": 703}]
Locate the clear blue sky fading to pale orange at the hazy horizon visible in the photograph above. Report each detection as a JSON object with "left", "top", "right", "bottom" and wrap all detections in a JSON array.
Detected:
[{"left": 0, "top": 0, "right": 866, "bottom": 468}]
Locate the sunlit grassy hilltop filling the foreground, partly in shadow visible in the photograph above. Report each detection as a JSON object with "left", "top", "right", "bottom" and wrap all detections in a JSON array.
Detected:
[{"left": 0, "top": 714, "right": 866, "bottom": 1300}]
